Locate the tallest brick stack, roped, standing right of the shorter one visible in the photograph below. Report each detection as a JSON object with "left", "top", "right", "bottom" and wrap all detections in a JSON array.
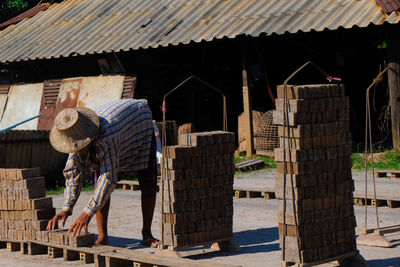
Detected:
[{"left": 273, "top": 84, "right": 356, "bottom": 263}]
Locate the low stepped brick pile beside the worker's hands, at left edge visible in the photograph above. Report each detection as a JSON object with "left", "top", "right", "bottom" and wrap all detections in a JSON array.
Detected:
[{"left": 0, "top": 168, "right": 55, "bottom": 241}]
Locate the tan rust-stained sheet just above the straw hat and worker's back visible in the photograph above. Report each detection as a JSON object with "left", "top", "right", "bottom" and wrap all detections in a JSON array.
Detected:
[{"left": 78, "top": 75, "right": 125, "bottom": 110}]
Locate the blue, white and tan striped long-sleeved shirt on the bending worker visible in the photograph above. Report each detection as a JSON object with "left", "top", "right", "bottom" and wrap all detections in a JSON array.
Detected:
[{"left": 63, "top": 99, "right": 153, "bottom": 216}]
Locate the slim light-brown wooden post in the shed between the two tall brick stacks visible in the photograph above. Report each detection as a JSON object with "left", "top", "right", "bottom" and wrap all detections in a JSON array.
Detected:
[{"left": 242, "top": 40, "right": 254, "bottom": 157}]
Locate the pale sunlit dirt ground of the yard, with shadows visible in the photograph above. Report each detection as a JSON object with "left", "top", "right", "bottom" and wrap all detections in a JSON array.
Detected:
[{"left": 0, "top": 169, "right": 400, "bottom": 267}]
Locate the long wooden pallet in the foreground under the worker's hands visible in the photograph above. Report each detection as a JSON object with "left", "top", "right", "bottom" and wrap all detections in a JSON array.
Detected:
[{"left": 0, "top": 240, "right": 239, "bottom": 267}]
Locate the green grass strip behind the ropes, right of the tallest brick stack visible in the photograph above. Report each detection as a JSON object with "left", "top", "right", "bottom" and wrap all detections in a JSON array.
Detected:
[{"left": 351, "top": 150, "right": 400, "bottom": 170}]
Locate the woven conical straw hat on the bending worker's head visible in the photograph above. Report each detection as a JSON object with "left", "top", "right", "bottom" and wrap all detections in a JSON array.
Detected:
[{"left": 50, "top": 108, "right": 100, "bottom": 153}]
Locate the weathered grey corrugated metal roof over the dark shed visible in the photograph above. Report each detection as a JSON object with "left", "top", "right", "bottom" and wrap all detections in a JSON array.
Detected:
[{"left": 0, "top": 0, "right": 400, "bottom": 62}]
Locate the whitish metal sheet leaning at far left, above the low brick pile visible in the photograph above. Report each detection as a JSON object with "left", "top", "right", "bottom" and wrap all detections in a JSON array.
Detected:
[{"left": 0, "top": 83, "right": 43, "bottom": 130}]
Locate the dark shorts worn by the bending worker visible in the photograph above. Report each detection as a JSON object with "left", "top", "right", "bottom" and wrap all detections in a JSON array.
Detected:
[{"left": 137, "top": 133, "right": 158, "bottom": 197}]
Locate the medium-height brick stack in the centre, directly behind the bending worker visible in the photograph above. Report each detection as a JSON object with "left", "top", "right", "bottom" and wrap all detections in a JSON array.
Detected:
[{"left": 160, "top": 131, "right": 235, "bottom": 248}]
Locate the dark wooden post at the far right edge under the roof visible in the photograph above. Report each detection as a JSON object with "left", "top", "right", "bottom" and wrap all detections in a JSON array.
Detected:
[{"left": 386, "top": 27, "right": 400, "bottom": 152}]
